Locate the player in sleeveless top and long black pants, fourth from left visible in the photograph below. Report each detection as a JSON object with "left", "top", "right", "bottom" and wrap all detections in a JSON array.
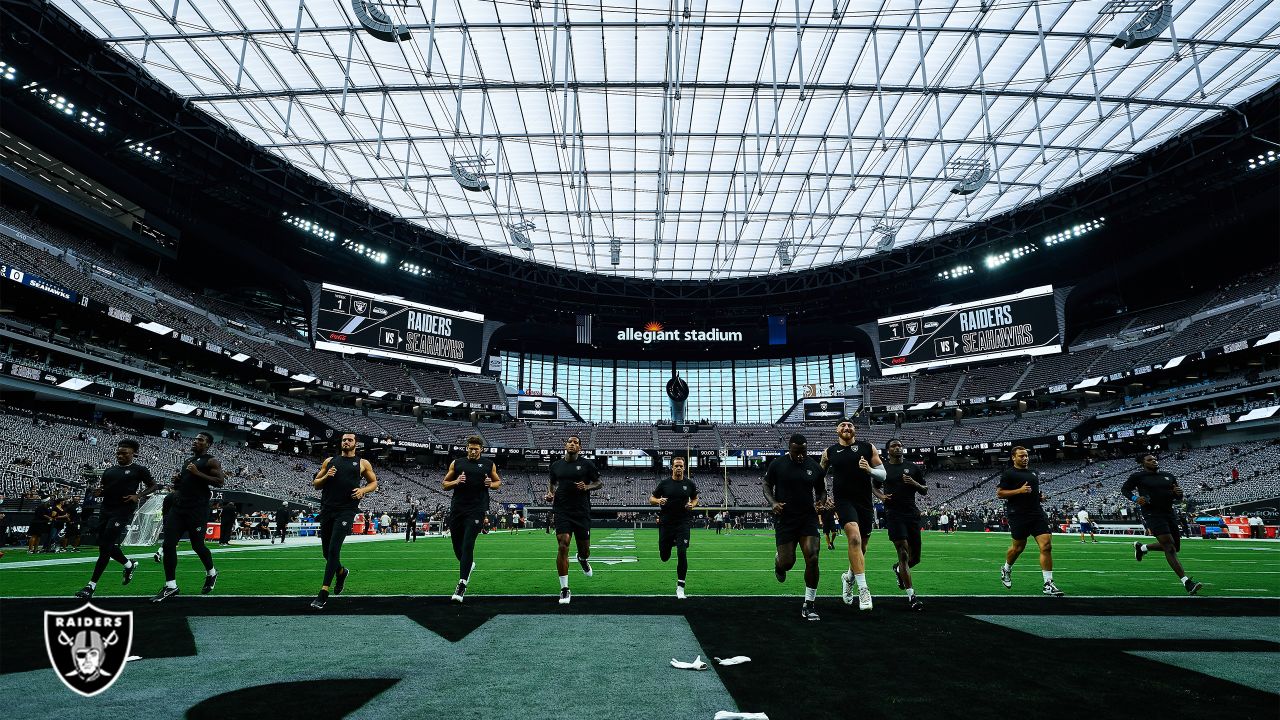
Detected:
[{"left": 444, "top": 436, "right": 502, "bottom": 602}]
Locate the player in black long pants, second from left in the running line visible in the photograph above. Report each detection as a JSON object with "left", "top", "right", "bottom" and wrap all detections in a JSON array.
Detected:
[{"left": 151, "top": 432, "right": 227, "bottom": 602}]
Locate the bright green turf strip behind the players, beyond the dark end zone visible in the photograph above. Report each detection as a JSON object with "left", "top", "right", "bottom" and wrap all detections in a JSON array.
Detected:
[{"left": 0, "top": 529, "right": 1280, "bottom": 597}]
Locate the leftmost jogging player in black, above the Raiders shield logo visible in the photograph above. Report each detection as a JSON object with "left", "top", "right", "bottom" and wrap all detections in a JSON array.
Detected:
[{"left": 76, "top": 439, "right": 156, "bottom": 600}]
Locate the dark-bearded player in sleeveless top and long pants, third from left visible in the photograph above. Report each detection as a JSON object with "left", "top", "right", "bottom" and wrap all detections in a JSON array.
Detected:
[{"left": 311, "top": 433, "right": 378, "bottom": 610}]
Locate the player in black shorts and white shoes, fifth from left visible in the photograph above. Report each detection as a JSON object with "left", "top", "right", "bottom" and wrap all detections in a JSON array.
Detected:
[{"left": 545, "top": 436, "right": 602, "bottom": 605}]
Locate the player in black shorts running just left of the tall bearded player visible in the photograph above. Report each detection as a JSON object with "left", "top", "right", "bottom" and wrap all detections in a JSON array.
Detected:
[{"left": 764, "top": 433, "right": 831, "bottom": 620}]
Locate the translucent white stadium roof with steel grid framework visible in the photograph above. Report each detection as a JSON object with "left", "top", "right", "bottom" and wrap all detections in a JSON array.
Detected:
[{"left": 54, "top": 0, "right": 1280, "bottom": 279}]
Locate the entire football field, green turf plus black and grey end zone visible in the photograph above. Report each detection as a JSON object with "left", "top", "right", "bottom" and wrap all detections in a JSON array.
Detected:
[{"left": 0, "top": 528, "right": 1280, "bottom": 720}]
